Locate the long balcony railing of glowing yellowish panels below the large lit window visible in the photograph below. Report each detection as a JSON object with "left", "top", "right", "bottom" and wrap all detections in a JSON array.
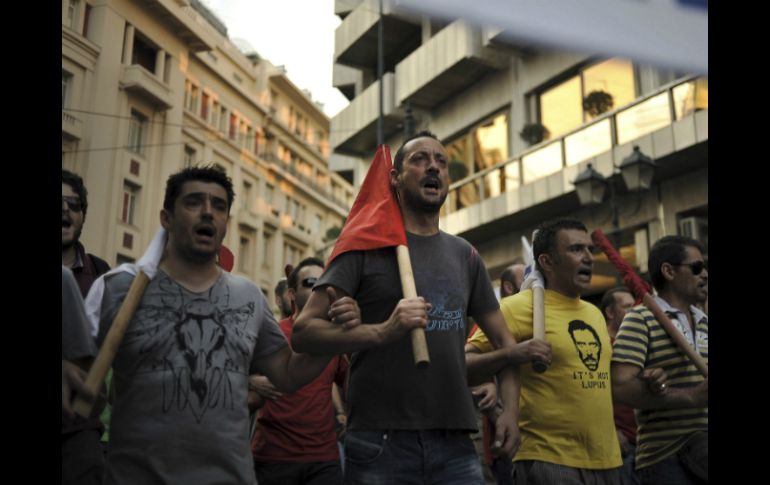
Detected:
[{"left": 442, "top": 77, "right": 708, "bottom": 214}]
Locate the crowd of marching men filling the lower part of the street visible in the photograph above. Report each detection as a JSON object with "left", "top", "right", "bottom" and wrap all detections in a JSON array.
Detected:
[{"left": 62, "top": 132, "right": 708, "bottom": 485}]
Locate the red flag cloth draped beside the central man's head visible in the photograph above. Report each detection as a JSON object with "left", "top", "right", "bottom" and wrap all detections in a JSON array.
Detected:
[{"left": 326, "top": 145, "right": 406, "bottom": 266}]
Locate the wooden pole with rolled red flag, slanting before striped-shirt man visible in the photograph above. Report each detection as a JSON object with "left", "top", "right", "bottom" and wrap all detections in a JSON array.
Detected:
[{"left": 591, "top": 229, "right": 709, "bottom": 377}]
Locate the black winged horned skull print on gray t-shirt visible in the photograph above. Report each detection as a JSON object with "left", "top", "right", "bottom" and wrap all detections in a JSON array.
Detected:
[{"left": 130, "top": 278, "right": 256, "bottom": 422}]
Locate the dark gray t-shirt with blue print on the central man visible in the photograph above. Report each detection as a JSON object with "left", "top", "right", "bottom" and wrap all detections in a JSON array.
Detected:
[{"left": 315, "top": 232, "right": 499, "bottom": 430}]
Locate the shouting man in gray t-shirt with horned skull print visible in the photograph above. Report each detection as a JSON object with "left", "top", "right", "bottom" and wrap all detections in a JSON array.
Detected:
[{"left": 91, "top": 167, "right": 329, "bottom": 484}]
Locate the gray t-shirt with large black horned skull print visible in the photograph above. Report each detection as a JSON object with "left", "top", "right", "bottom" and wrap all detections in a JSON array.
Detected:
[{"left": 99, "top": 271, "right": 287, "bottom": 484}]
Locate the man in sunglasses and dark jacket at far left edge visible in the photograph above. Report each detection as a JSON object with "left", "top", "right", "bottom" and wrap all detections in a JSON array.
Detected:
[{"left": 61, "top": 169, "right": 110, "bottom": 298}]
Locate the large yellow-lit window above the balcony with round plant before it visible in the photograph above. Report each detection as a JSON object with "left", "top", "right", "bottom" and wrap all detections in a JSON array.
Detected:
[{"left": 539, "top": 58, "right": 636, "bottom": 139}]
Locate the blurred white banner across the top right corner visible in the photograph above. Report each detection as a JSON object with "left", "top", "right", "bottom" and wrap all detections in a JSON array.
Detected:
[{"left": 395, "top": 0, "right": 708, "bottom": 74}]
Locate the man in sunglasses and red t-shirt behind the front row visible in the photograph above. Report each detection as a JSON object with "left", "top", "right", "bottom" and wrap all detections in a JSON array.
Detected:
[{"left": 251, "top": 258, "right": 348, "bottom": 485}]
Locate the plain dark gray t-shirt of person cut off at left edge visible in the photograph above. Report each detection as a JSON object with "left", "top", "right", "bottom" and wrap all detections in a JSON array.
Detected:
[{"left": 61, "top": 266, "right": 96, "bottom": 361}]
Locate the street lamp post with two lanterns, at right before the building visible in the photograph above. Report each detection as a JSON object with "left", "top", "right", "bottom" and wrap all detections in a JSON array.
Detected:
[{"left": 572, "top": 146, "right": 657, "bottom": 250}]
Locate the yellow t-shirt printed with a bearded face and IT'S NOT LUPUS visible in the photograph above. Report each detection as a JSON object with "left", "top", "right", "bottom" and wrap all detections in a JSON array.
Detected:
[{"left": 469, "top": 290, "right": 622, "bottom": 469}]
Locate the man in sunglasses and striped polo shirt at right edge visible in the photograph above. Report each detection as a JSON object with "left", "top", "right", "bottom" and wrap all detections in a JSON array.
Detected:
[{"left": 612, "top": 236, "right": 708, "bottom": 484}]
